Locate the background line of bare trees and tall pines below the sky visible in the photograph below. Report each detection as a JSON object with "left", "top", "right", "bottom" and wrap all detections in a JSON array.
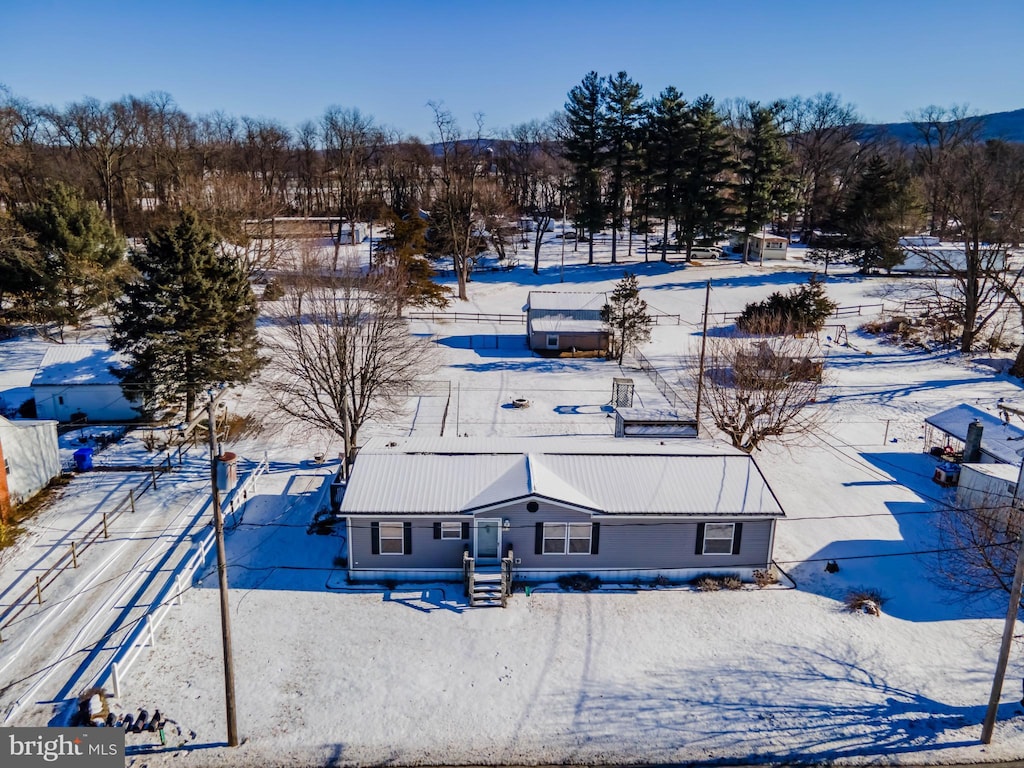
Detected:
[{"left": 0, "top": 72, "right": 1024, "bottom": 397}]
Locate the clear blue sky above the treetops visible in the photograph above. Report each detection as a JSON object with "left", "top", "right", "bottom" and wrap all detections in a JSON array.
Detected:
[{"left": 0, "top": 0, "right": 1024, "bottom": 138}]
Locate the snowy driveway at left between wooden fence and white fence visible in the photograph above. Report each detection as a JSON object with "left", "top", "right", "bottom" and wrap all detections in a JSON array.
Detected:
[{"left": 0, "top": 462, "right": 209, "bottom": 724}]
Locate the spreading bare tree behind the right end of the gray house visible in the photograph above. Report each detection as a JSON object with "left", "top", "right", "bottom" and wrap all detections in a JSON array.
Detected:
[{"left": 690, "top": 325, "right": 822, "bottom": 453}]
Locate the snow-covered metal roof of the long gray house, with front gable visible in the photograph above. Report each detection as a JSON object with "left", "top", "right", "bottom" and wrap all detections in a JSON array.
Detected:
[{"left": 341, "top": 437, "right": 783, "bottom": 517}]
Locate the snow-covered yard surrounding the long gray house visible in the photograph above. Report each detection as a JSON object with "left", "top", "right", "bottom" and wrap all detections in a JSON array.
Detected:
[{"left": 6, "top": 237, "right": 1024, "bottom": 766}]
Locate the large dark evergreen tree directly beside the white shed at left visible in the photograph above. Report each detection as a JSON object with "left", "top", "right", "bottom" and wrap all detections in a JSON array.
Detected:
[{"left": 111, "top": 213, "right": 263, "bottom": 418}]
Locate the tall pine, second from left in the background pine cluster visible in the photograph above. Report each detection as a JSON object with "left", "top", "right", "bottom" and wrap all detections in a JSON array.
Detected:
[{"left": 604, "top": 72, "right": 643, "bottom": 264}]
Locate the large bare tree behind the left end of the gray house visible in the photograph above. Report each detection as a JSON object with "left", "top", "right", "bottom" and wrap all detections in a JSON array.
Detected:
[{"left": 265, "top": 252, "right": 433, "bottom": 476}]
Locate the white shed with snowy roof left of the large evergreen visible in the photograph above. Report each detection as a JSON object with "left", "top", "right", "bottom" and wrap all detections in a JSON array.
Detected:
[{"left": 32, "top": 344, "right": 141, "bottom": 424}]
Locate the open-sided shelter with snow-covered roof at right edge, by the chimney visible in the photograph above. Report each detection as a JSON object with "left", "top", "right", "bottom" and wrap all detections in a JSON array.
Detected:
[{"left": 925, "top": 402, "right": 1024, "bottom": 467}]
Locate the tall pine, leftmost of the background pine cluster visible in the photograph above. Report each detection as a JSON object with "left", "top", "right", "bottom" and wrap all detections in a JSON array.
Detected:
[{"left": 564, "top": 72, "right": 606, "bottom": 264}]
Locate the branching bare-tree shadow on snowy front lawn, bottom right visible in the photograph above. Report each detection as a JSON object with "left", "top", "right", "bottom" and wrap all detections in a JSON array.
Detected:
[{"left": 542, "top": 639, "right": 991, "bottom": 764}]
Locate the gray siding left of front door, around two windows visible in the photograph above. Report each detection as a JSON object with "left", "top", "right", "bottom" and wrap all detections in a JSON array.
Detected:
[{"left": 348, "top": 516, "right": 473, "bottom": 570}]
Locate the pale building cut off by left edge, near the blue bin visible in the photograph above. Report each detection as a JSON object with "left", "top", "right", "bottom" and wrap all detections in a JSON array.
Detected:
[{"left": 0, "top": 416, "right": 60, "bottom": 509}]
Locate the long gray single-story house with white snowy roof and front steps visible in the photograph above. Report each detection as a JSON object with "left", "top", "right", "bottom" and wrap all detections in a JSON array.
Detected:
[{"left": 339, "top": 437, "right": 784, "bottom": 583}]
